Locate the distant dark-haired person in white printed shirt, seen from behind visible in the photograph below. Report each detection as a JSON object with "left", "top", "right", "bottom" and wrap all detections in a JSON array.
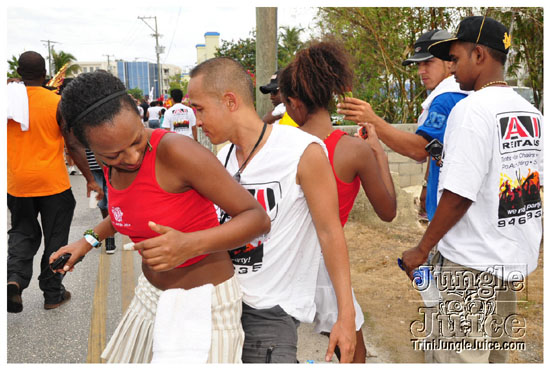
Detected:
[{"left": 162, "top": 89, "right": 197, "bottom": 141}]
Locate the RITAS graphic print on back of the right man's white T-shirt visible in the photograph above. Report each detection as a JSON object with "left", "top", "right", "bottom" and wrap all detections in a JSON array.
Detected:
[{"left": 498, "top": 112, "right": 542, "bottom": 227}]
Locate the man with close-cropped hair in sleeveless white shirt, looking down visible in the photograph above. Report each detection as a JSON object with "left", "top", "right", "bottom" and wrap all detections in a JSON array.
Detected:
[{"left": 188, "top": 58, "right": 356, "bottom": 363}]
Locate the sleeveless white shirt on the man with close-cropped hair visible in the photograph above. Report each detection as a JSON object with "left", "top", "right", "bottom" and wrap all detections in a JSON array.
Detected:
[{"left": 218, "top": 125, "right": 326, "bottom": 322}]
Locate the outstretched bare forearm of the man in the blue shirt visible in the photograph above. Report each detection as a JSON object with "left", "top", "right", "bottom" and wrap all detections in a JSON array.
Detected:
[{"left": 338, "top": 97, "right": 434, "bottom": 162}]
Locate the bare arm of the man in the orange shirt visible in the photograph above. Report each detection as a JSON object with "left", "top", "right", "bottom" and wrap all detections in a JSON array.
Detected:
[{"left": 56, "top": 104, "right": 104, "bottom": 199}]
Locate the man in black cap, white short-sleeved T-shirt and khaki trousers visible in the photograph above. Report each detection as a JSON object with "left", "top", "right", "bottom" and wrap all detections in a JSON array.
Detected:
[{"left": 402, "top": 16, "right": 543, "bottom": 362}]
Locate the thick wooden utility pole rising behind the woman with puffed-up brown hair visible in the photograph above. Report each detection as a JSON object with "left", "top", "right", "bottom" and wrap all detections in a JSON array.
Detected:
[{"left": 256, "top": 7, "right": 277, "bottom": 117}]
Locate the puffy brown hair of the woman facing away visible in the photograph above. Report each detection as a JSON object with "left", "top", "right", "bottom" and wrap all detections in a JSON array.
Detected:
[{"left": 279, "top": 41, "right": 353, "bottom": 112}]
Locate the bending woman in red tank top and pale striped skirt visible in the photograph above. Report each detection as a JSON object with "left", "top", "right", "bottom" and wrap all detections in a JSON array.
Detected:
[{"left": 50, "top": 72, "right": 270, "bottom": 362}]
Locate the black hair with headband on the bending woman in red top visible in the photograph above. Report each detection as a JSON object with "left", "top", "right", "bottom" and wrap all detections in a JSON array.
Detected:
[{"left": 60, "top": 70, "right": 139, "bottom": 148}]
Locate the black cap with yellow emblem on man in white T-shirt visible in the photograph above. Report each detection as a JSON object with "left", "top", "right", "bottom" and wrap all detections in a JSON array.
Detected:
[{"left": 428, "top": 16, "right": 512, "bottom": 60}]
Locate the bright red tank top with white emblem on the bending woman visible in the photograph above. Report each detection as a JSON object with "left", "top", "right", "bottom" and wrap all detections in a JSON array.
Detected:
[{"left": 103, "top": 129, "right": 219, "bottom": 267}]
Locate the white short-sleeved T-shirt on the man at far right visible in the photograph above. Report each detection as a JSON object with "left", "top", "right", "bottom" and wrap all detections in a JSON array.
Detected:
[{"left": 438, "top": 87, "right": 543, "bottom": 281}]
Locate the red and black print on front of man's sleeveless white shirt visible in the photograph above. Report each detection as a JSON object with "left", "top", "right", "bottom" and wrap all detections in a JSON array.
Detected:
[{"left": 229, "top": 181, "right": 282, "bottom": 274}]
